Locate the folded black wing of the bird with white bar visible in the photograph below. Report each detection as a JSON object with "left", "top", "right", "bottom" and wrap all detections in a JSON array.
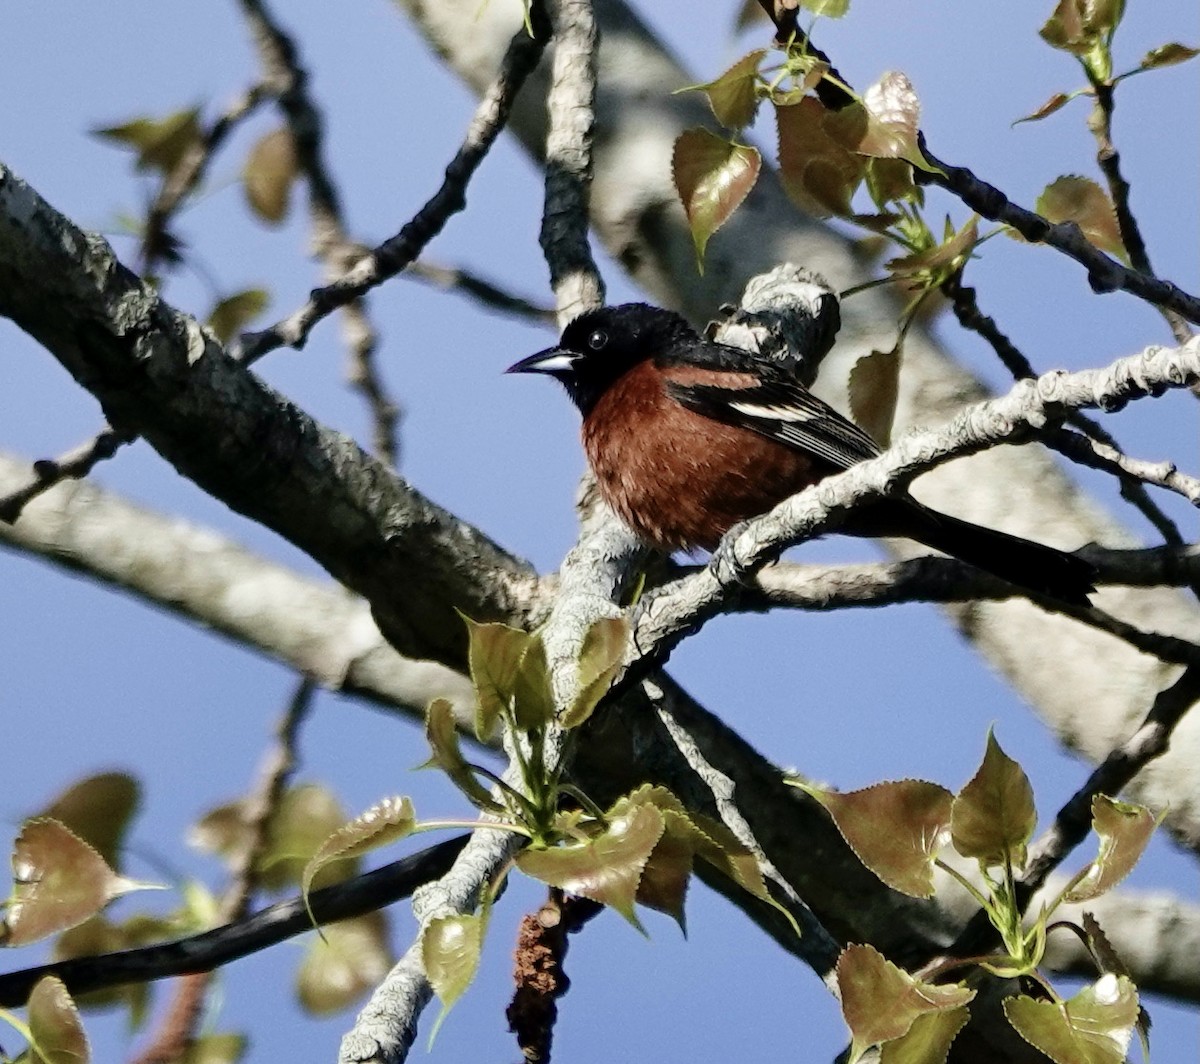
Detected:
[{"left": 667, "top": 375, "right": 880, "bottom": 469}]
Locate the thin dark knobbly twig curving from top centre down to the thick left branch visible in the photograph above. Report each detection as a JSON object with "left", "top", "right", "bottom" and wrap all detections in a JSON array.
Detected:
[{"left": 239, "top": 5, "right": 546, "bottom": 365}]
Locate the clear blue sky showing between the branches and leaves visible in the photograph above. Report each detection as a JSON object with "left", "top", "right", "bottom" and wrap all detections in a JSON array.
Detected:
[{"left": 0, "top": 0, "right": 1200, "bottom": 1064}]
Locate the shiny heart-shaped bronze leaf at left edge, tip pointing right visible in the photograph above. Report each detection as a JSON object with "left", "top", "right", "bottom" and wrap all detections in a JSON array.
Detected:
[{"left": 0, "top": 817, "right": 149, "bottom": 946}]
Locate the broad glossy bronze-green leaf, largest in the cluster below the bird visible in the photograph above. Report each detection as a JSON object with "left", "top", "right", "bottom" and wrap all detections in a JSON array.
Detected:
[{"left": 516, "top": 798, "right": 666, "bottom": 930}]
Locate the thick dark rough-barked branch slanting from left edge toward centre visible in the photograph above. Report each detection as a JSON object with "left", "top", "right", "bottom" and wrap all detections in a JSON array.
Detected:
[{"left": 0, "top": 167, "right": 536, "bottom": 663}]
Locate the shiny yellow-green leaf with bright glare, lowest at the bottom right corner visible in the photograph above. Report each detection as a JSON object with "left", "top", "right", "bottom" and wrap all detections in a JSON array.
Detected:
[{"left": 1004, "top": 974, "right": 1138, "bottom": 1064}]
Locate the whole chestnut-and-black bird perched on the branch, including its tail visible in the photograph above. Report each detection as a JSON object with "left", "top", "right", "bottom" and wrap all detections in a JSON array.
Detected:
[{"left": 506, "top": 303, "right": 1096, "bottom": 605}]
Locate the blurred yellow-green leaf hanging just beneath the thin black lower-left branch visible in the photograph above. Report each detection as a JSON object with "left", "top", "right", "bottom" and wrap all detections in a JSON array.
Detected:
[{"left": 296, "top": 912, "right": 392, "bottom": 1016}]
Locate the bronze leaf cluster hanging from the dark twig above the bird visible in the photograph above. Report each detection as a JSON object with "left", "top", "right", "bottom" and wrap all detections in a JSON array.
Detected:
[{"left": 672, "top": 4, "right": 980, "bottom": 445}]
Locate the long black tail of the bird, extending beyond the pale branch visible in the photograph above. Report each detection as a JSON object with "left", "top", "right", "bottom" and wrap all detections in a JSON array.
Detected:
[{"left": 864, "top": 500, "right": 1097, "bottom": 606}]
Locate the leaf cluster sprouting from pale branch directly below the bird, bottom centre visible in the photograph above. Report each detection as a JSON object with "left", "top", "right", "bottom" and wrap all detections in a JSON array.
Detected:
[{"left": 393, "top": 618, "right": 796, "bottom": 1030}]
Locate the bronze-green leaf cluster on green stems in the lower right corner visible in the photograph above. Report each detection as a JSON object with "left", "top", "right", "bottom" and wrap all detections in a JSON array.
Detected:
[{"left": 797, "top": 734, "right": 1158, "bottom": 1064}]
